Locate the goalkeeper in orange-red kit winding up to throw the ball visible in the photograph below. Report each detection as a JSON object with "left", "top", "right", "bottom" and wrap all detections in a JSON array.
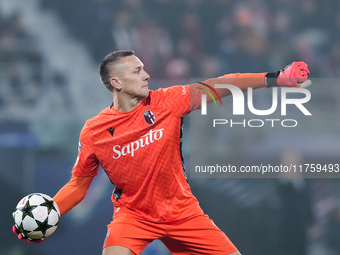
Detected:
[{"left": 15, "top": 51, "right": 309, "bottom": 255}]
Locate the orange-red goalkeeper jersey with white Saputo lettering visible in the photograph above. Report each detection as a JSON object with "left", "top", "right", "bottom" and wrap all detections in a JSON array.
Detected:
[{"left": 72, "top": 85, "right": 201, "bottom": 221}]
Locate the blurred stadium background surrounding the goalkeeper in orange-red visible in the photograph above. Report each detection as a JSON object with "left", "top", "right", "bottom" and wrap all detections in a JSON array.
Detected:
[{"left": 0, "top": 0, "right": 340, "bottom": 255}]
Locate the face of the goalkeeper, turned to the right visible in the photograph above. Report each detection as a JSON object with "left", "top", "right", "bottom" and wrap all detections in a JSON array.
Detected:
[{"left": 113, "top": 55, "right": 150, "bottom": 98}]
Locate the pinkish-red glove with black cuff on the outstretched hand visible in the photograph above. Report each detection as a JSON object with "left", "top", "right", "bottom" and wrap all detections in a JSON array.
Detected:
[{"left": 265, "top": 61, "right": 310, "bottom": 88}]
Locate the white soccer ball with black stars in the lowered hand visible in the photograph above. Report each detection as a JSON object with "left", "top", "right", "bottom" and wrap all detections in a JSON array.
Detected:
[{"left": 13, "top": 193, "right": 60, "bottom": 240}]
